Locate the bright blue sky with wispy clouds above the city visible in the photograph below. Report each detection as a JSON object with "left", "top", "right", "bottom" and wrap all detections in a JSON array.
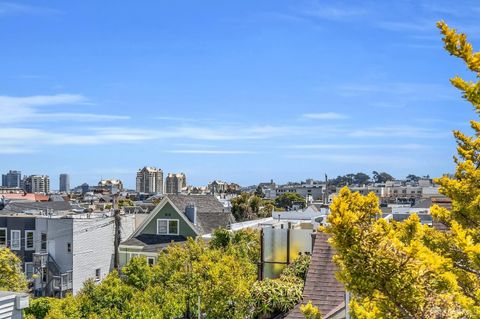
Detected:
[{"left": 0, "top": 0, "right": 480, "bottom": 188}]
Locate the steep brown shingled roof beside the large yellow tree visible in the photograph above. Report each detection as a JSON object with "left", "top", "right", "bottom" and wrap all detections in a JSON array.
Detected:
[{"left": 285, "top": 232, "right": 345, "bottom": 319}]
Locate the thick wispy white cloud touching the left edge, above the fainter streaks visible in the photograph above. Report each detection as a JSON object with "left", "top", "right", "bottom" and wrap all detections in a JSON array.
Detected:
[{"left": 0, "top": 94, "right": 130, "bottom": 124}]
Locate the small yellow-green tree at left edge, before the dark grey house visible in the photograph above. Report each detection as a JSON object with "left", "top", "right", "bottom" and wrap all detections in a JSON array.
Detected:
[{"left": 0, "top": 248, "right": 27, "bottom": 291}]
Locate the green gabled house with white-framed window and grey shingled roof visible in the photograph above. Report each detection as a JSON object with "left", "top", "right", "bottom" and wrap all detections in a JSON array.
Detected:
[{"left": 119, "top": 195, "right": 235, "bottom": 266}]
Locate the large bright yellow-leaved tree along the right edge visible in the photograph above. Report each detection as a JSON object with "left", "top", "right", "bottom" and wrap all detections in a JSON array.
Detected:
[{"left": 323, "top": 22, "right": 480, "bottom": 319}]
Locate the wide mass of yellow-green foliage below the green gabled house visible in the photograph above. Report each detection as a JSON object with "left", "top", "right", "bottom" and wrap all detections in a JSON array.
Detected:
[{"left": 27, "top": 238, "right": 256, "bottom": 319}]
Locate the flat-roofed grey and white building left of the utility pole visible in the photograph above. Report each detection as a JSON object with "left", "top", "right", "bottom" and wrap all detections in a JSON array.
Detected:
[{"left": 0, "top": 209, "right": 135, "bottom": 297}]
